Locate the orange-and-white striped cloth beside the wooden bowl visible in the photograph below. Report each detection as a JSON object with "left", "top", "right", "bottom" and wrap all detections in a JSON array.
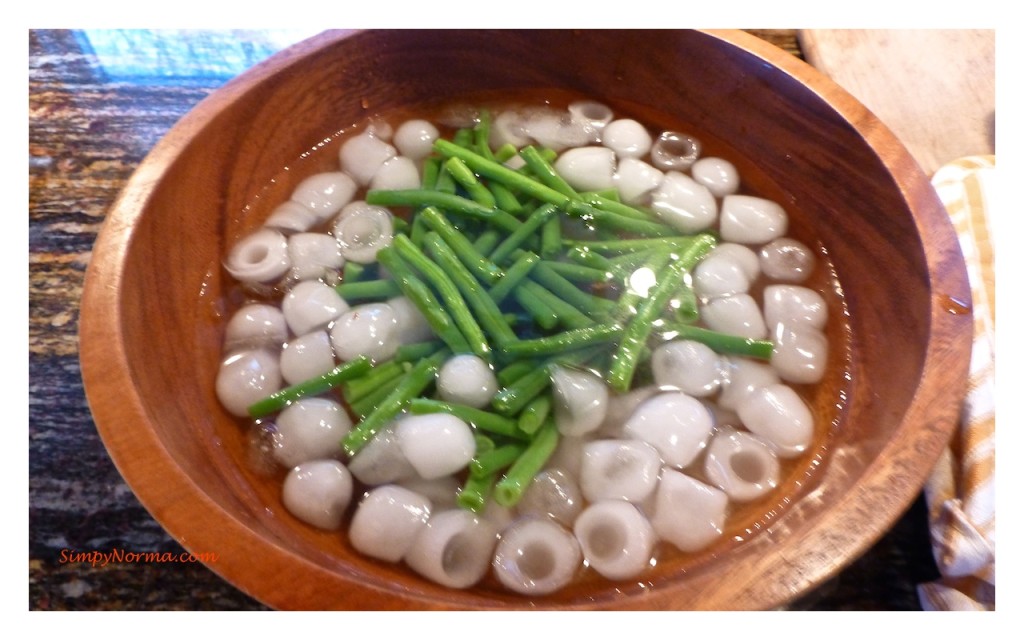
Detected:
[{"left": 918, "top": 156, "right": 995, "bottom": 610}]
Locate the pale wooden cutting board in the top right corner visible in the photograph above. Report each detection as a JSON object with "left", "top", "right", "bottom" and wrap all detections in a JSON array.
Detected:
[{"left": 798, "top": 29, "right": 995, "bottom": 175}]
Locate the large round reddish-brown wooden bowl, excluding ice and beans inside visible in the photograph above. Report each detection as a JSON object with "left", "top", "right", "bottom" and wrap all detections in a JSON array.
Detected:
[{"left": 81, "top": 30, "right": 972, "bottom": 609}]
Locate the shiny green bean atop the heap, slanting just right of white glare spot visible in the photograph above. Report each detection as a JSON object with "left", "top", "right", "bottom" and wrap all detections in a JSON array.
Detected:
[{"left": 607, "top": 233, "right": 715, "bottom": 392}]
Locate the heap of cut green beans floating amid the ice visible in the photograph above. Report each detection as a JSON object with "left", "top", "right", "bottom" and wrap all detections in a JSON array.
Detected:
[{"left": 250, "top": 112, "right": 771, "bottom": 511}]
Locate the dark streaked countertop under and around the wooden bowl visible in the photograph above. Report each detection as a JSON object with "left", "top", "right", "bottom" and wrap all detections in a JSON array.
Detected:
[{"left": 29, "top": 31, "right": 937, "bottom": 610}]
